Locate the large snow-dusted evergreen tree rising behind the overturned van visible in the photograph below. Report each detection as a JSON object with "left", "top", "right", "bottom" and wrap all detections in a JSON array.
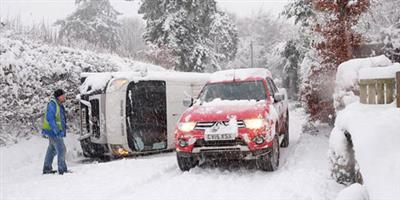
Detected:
[{"left": 139, "top": 0, "right": 237, "bottom": 72}]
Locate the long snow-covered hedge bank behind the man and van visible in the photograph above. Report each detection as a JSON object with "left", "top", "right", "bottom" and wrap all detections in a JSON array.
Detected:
[{"left": 0, "top": 29, "right": 163, "bottom": 144}]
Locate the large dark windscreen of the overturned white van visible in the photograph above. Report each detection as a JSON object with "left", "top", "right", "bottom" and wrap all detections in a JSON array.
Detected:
[{"left": 126, "top": 81, "right": 167, "bottom": 152}]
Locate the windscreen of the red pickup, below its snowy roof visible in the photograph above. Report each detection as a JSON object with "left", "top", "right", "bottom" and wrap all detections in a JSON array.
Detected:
[{"left": 199, "top": 80, "right": 267, "bottom": 102}]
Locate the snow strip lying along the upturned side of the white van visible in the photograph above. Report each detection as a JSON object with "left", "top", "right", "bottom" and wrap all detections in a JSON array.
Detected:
[{"left": 80, "top": 71, "right": 210, "bottom": 94}]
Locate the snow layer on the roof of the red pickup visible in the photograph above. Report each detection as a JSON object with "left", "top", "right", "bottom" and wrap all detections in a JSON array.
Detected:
[{"left": 210, "top": 68, "right": 272, "bottom": 82}]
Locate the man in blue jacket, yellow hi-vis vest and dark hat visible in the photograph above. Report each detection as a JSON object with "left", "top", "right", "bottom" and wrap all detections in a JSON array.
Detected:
[{"left": 42, "top": 89, "right": 69, "bottom": 175}]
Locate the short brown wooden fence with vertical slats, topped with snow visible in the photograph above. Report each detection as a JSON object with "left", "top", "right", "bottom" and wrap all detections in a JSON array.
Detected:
[{"left": 360, "top": 72, "right": 400, "bottom": 108}]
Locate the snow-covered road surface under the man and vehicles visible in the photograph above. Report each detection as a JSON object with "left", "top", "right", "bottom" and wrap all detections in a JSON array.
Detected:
[{"left": 0, "top": 105, "right": 344, "bottom": 200}]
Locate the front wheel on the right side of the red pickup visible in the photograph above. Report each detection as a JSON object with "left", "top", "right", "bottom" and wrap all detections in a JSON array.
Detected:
[{"left": 256, "top": 137, "right": 280, "bottom": 171}]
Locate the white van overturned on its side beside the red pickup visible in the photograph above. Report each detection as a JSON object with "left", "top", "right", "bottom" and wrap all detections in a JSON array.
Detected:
[{"left": 79, "top": 71, "right": 209, "bottom": 157}]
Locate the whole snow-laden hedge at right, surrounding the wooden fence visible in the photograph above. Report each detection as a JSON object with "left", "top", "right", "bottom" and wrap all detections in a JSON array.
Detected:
[{"left": 329, "top": 56, "right": 400, "bottom": 199}]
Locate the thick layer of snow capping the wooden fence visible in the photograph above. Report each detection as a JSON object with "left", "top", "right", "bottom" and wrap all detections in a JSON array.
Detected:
[{"left": 359, "top": 63, "right": 400, "bottom": 79}]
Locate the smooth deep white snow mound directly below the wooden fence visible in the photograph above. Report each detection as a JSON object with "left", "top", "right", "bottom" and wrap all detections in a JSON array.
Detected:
[{"left": 330, "top": 102, "right": 400, "bottom": 199}]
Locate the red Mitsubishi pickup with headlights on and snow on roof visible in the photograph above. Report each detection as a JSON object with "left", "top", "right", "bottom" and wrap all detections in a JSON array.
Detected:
[{"left": 175, "top": 68, "right": 289, "bottom": 171}]
